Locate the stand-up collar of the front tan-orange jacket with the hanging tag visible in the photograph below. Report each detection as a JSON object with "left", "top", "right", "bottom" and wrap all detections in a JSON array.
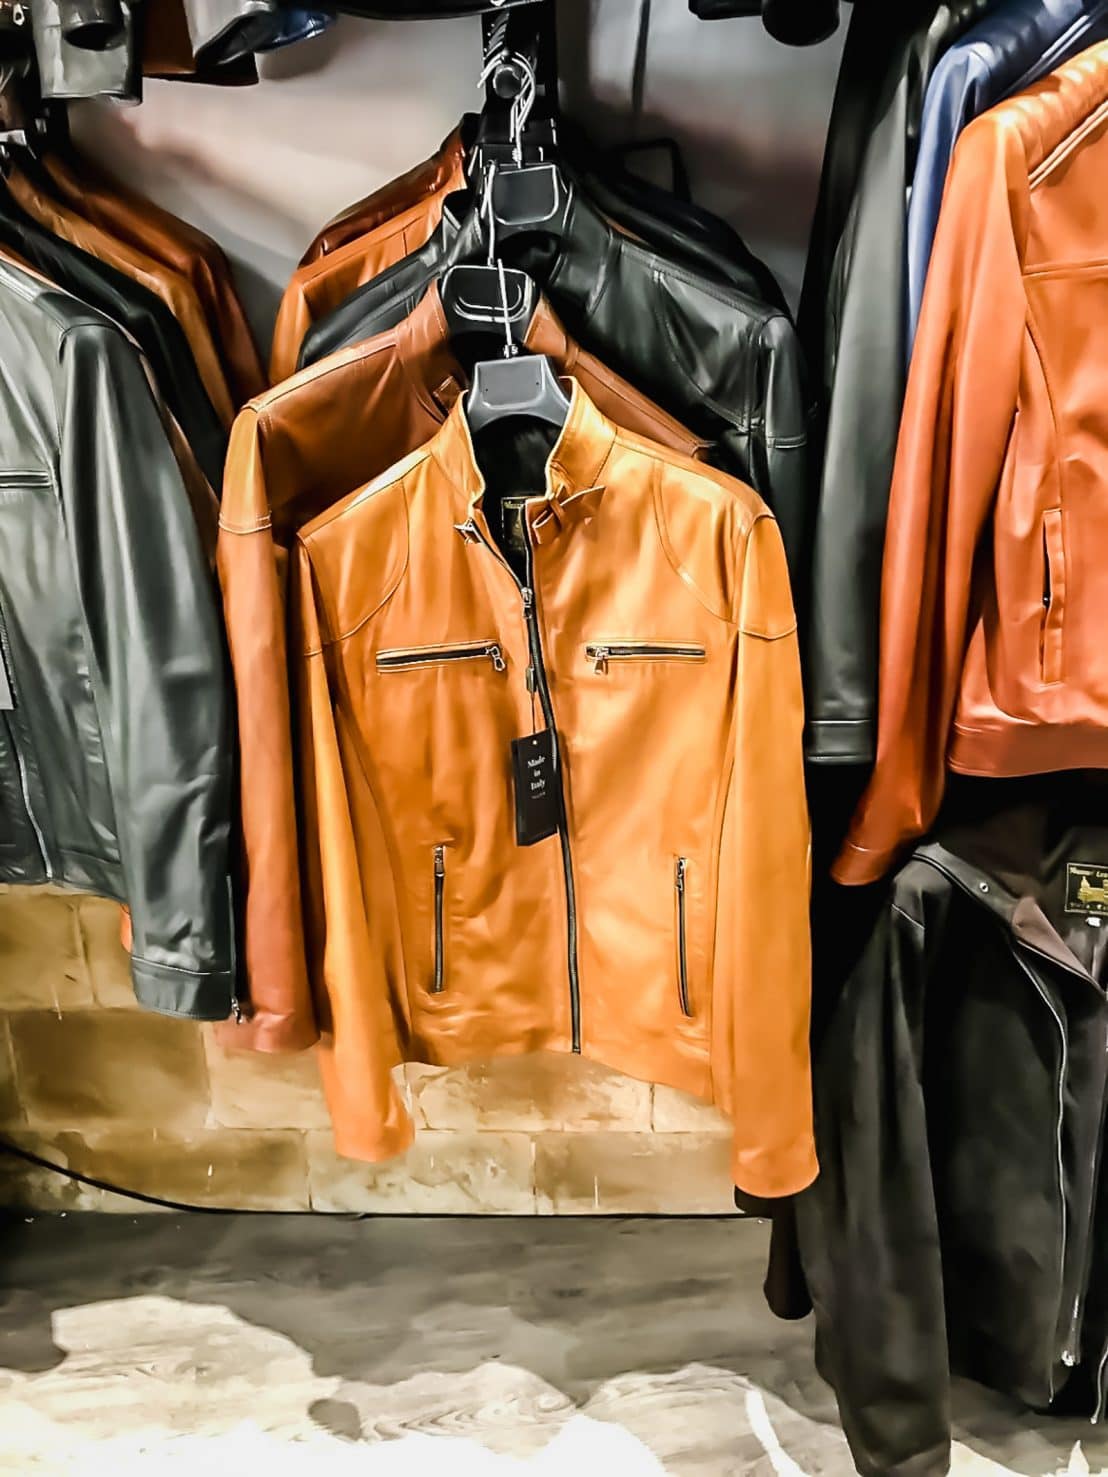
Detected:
[{"left": 430, "top": 380, "right": 616, "bottom": 544}]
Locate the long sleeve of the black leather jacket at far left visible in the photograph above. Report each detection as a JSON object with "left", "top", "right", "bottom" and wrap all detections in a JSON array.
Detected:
[{"left": 59, "top": 323, "right": 233, "bottom": 1021}]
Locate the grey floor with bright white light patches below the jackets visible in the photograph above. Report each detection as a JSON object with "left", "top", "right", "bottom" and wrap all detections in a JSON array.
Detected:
[{"left": 0, "top": 1214, "right": 1108, "bottom": 1477}]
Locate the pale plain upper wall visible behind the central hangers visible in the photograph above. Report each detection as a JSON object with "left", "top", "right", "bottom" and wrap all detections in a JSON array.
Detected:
[{"left": 75, "top": 0, "right": 841, "bottom": 354}]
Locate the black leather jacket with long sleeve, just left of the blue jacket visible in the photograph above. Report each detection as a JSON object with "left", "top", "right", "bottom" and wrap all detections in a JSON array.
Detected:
[{"left": 799, "top": 0, "right": 988, "bottom": 764}]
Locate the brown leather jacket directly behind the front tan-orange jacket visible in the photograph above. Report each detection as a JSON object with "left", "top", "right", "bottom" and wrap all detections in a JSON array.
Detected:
[{"left": 219, "top": 288, "right": 705, "bottom": 1052}]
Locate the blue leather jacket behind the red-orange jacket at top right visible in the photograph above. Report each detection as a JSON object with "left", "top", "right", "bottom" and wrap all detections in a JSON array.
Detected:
[{"left": 906, "top": 0, "right": 1108, "bottom": 359}]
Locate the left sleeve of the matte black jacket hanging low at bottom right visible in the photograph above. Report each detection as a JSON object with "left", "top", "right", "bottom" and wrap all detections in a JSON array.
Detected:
[{"left": 796, "top": 905, "right": 950, "bottom": 1477}]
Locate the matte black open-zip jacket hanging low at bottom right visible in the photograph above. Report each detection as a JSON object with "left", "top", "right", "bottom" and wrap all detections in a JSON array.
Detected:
[{"left": 798, "top": 775, "right": 1108, "bottom": 1477}]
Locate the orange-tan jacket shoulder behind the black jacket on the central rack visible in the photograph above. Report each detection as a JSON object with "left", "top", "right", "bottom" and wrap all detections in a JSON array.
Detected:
[{"left": 277, "top": 152, "right": 464, "bottom": 384}]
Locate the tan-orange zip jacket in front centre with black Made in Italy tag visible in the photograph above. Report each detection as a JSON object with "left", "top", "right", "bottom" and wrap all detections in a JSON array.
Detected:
[{"left": 294, "top": 381, "right": 815, "bottom": 1196}]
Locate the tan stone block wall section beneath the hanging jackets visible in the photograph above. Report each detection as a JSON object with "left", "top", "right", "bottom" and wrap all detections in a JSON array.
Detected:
[{"left": 0, "top": 888, "right": 733, "bottom": 1216}]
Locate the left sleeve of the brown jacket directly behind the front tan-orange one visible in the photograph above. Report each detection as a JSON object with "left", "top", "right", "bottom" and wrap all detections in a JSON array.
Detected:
[{"left": 217, "top": 406, "right": 319, "bottom": 1052}]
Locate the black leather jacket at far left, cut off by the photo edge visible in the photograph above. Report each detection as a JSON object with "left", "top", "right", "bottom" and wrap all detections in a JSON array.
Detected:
[{"left": 0, "top": 263, "right": 233, "bottom": 1019}]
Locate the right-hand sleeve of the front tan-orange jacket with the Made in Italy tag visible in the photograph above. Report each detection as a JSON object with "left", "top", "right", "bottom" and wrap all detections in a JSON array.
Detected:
[{"left": 712, "top": 514, "right": 815, "bottom": 1196}]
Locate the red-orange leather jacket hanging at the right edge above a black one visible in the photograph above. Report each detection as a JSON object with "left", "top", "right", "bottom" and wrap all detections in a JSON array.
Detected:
[{"left": 835, "top": 43, "right": 1108, "bottom": 883}]
